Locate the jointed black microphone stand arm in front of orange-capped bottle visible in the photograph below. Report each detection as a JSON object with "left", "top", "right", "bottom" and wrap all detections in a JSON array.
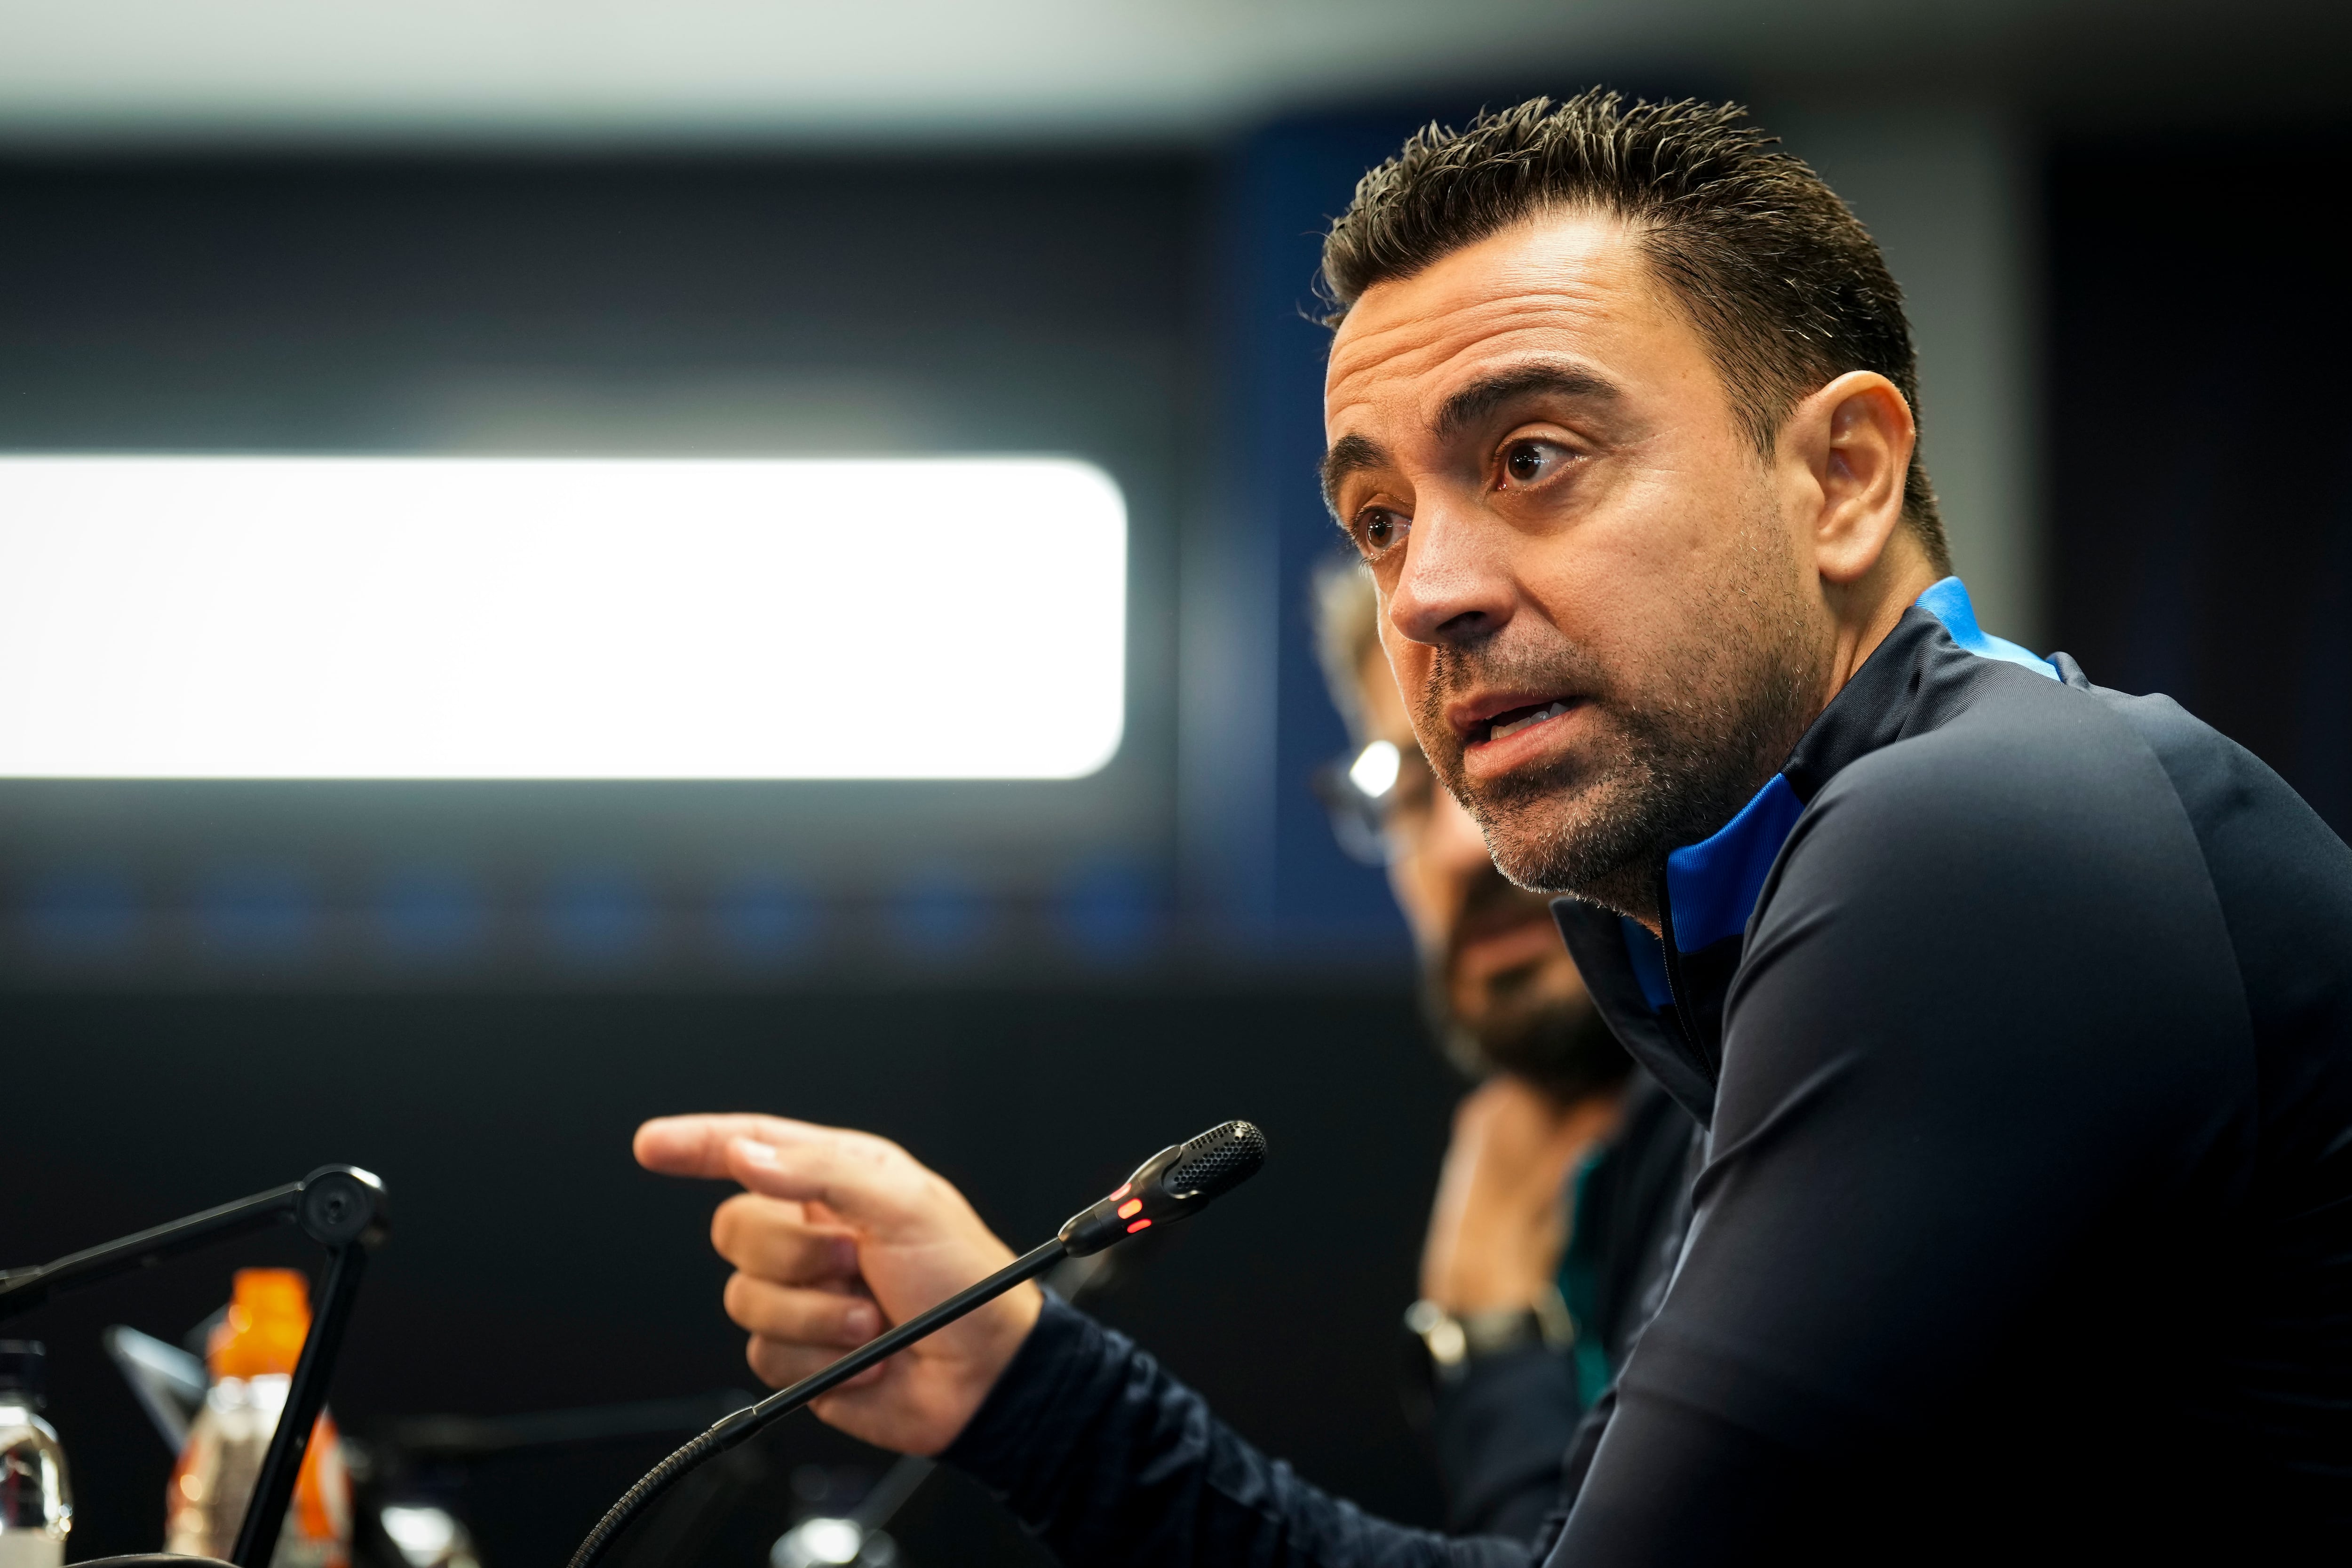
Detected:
[{"left": 0, "top": 1166, "right": 388, "bottom": 1568}]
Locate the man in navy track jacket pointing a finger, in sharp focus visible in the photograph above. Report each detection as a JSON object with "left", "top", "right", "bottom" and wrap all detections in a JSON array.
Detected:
[{"left": 637, "top": 94, "right": 2352, "bottom": 1568}]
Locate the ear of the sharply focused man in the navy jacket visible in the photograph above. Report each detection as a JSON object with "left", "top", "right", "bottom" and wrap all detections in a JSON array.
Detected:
[{"left": 1780, "top": 369, "right": 1919, "bottom": 588}]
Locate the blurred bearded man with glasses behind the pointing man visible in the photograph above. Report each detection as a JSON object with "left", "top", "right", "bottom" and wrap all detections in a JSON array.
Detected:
[{"left": 1315, "top": 562, "right": 1698, "bottom": 1537}]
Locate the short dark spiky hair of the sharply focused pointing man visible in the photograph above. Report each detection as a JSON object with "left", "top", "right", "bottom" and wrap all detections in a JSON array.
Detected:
[{"left": 1322, "top": 89, "right": 1952, "bottom": 571}]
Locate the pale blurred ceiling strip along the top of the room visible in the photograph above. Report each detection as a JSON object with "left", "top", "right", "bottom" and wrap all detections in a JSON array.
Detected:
[{"left": 0, "top": 0, "right": 2331, "bottom": 146}]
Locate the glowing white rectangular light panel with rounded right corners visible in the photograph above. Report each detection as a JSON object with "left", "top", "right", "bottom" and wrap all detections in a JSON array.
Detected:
[{"left": 0, "top": 456, "right": 1127, "bottom": 778}]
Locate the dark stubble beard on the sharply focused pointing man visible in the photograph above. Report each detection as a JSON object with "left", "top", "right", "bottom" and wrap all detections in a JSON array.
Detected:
[{"left": 1418, "top": 519, "right": 1828, "bottom": 922}]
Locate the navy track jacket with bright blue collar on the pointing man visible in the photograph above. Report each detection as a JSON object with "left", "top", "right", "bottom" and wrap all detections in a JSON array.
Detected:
[{"left": 948, "top": 578, "right": 2352, "bottom": 1568}]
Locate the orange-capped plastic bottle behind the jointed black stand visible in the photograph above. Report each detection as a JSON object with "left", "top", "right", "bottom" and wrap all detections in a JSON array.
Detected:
[{"left": 165, "top": 1269, "right": 350, "bottom": 1568}]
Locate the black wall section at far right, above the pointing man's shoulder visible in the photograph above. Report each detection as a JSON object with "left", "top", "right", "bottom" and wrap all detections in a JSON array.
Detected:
[{"left": 2049, "top": 132, "right": 2352, "bottom": 835}]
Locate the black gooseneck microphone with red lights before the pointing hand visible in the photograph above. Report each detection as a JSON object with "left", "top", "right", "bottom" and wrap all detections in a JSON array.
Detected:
[{"left": 569, "top": 1122, "right": 1265, "bottom": 1568}]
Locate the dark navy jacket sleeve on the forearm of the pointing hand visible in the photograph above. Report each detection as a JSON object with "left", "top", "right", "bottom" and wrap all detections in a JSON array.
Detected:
[{"left": 941, "top": 1295, "right": 1557, "bottom": 1568}]
